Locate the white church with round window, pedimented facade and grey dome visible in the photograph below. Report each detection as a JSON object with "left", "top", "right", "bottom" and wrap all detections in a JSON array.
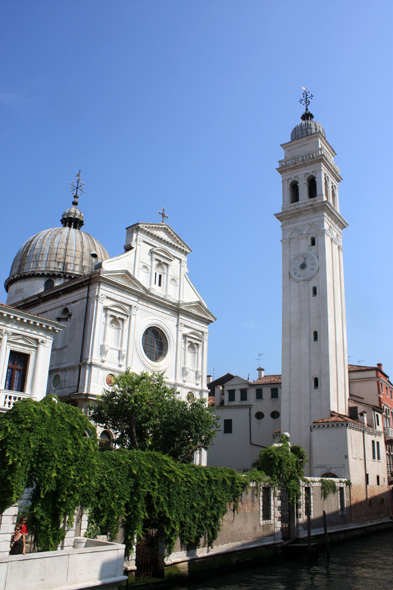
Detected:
[{"left": 5, "top": 175, "right": 215, "bottom": 440}]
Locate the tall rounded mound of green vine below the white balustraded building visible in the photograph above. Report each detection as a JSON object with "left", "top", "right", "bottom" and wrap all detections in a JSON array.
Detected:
[{"left": 0, "top": 397, "right": 98, "bottom": 550}]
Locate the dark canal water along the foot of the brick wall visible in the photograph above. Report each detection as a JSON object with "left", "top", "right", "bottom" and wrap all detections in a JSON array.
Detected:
[{"left": 178, "top": 531, "right": 393, "bottom": 590}]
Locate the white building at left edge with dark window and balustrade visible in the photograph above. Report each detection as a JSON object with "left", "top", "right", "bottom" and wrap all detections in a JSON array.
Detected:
[{"left": 0, "top": 304, "right": 63, "bottom": 412}]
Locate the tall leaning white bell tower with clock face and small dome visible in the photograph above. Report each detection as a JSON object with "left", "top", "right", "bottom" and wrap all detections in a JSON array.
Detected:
[{"left": 276, "top": 90, "right": 349, "bottom": 475}]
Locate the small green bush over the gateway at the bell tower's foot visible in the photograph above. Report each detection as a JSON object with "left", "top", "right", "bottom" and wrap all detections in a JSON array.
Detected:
[{"left": 253, "top": 435, "right": 307, "bottom": 505}]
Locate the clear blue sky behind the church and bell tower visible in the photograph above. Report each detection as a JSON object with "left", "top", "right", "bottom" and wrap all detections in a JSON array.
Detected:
[{"left": 0, "top": 0, "right": 393, "bottom": 379}]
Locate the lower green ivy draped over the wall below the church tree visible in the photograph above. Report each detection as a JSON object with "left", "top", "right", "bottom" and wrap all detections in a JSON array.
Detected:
[{"left": 91, "top": 449, "right": 266, "bottom": 553}]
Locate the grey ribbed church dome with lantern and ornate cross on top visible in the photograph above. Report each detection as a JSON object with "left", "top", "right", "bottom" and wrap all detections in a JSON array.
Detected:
[{"left": 4, "top": 177, "right": 109, "bottom": 292}]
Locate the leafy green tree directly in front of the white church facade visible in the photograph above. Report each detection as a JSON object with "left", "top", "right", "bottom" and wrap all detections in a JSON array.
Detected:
[{"left": 89, "top": 370, "right": 219, "bottom": 463}]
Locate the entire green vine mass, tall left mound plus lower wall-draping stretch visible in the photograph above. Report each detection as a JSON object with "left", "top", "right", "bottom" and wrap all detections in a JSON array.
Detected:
[{"left": 0, "top": 397, "right": 266, "bottom": 552}]
